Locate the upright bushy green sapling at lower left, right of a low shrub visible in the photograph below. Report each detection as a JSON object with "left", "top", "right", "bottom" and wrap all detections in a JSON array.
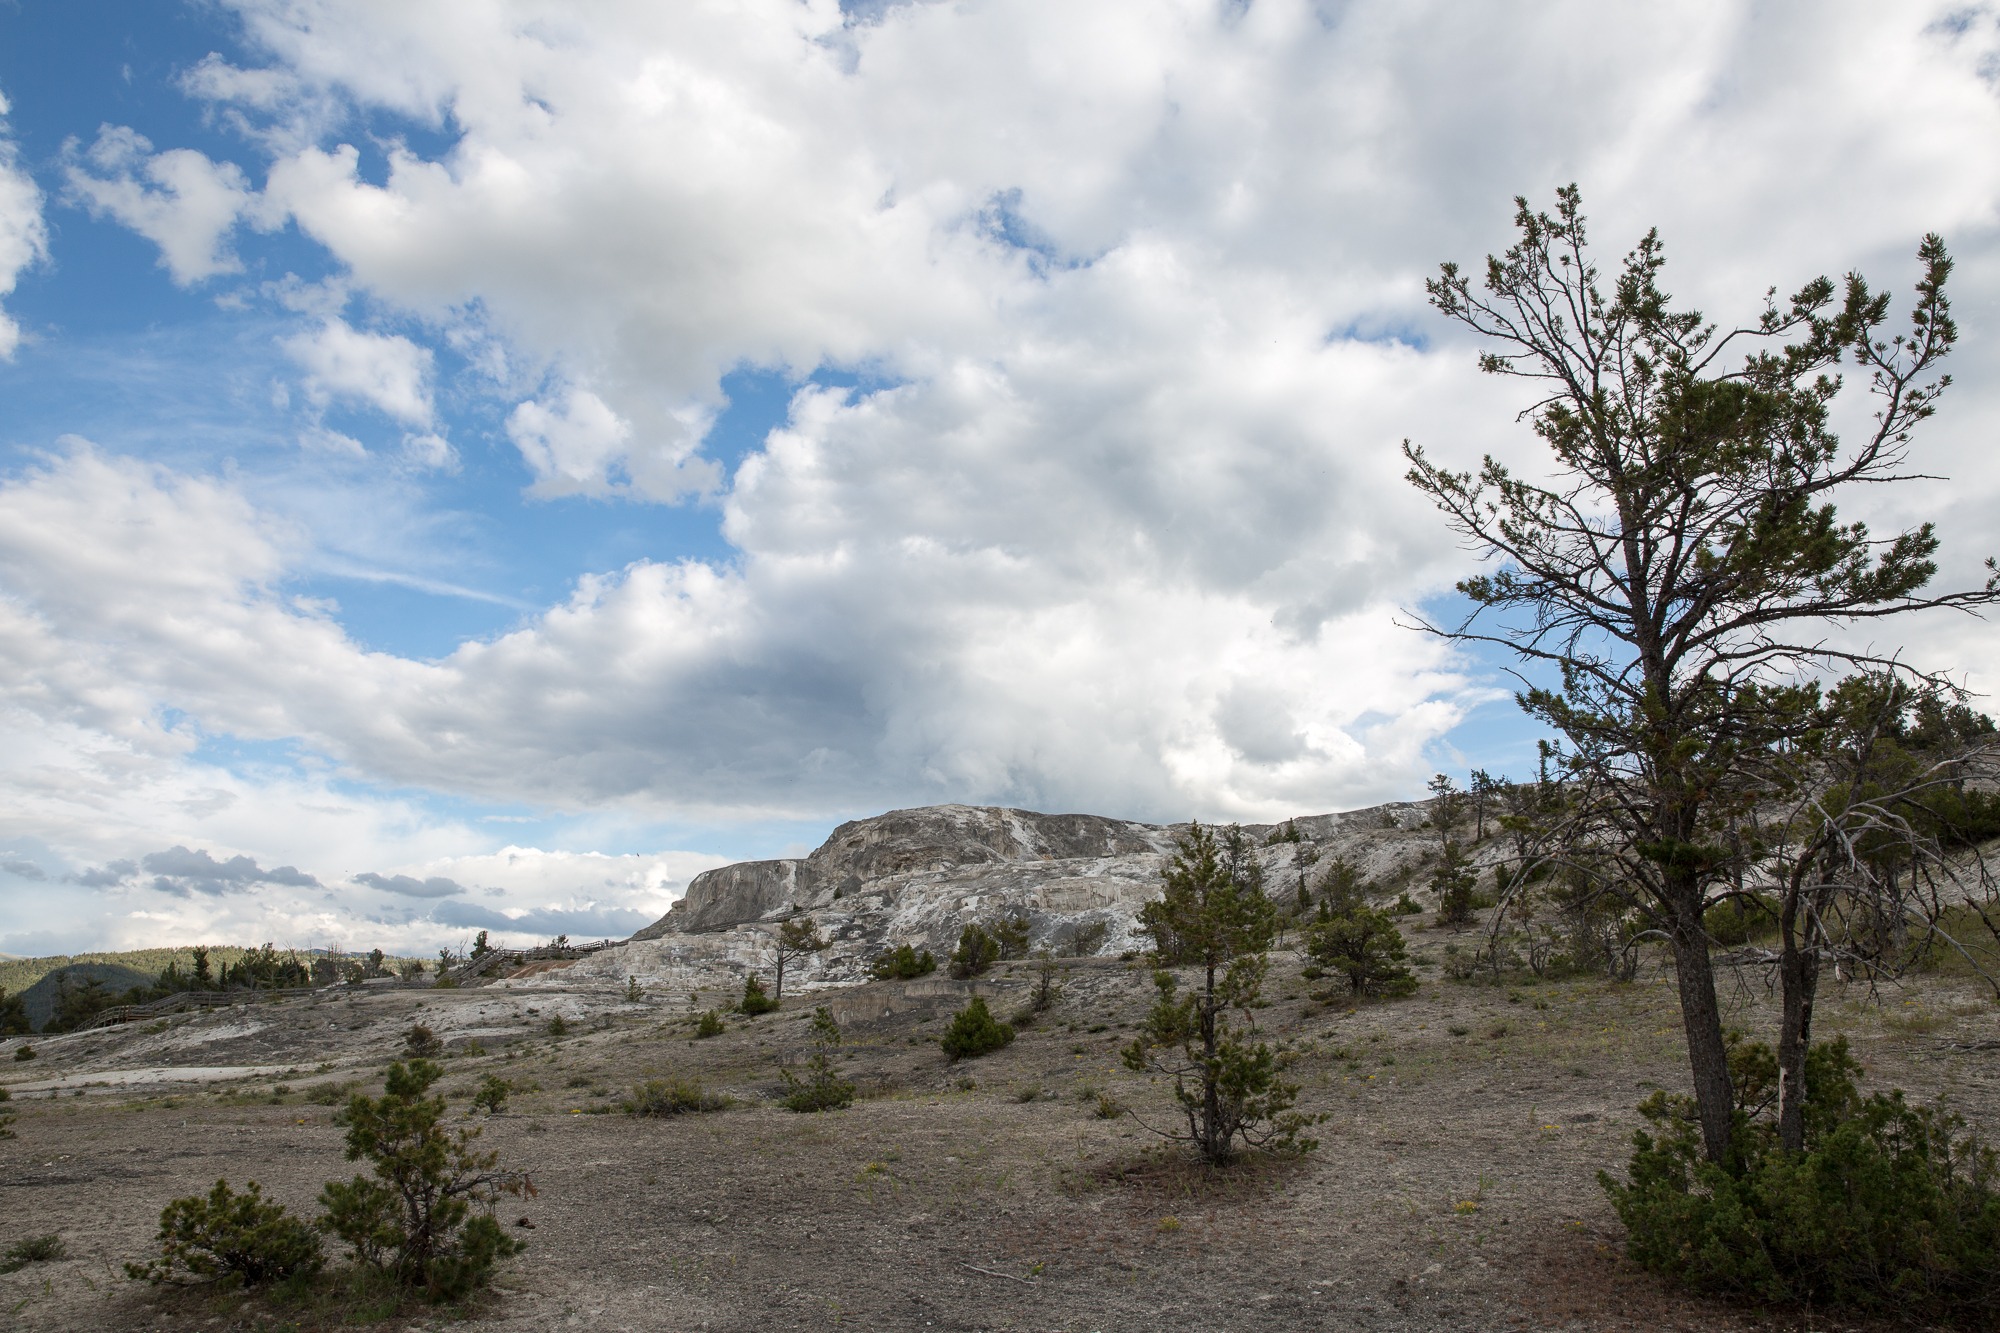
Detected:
[{"left": 320, "top": 1061, "right": 526, "bottom": 1301}]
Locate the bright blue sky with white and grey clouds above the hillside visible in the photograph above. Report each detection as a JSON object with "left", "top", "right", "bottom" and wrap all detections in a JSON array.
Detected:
[{"left": 0, "top": 0, "right": 2000, "bottom": 953}]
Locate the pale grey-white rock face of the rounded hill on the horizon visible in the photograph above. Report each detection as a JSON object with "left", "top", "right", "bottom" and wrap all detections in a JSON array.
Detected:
[{"left": 566, "top": 788, "right": 1436, "bottom": 993}]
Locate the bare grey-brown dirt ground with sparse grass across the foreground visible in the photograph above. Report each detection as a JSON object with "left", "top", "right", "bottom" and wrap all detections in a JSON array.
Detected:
[{"left": 0, "top": 932, "right": 2000, "bottom": 1333}]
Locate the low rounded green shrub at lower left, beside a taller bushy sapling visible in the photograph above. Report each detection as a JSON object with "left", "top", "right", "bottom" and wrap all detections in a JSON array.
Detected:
[{"left": 124, "top": 1181, "right": 324, "bottom": 1287}]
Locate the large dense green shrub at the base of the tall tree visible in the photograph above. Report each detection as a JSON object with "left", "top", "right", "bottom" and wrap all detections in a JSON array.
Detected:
[{"left": 1598, "top": 1037, "right": 2000, "bottom": 1327}]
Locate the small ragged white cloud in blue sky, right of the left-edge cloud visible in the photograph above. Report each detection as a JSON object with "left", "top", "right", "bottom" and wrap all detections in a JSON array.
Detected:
[{"left": 64, "top": 124, "right": 254, "bottom": 286}]
